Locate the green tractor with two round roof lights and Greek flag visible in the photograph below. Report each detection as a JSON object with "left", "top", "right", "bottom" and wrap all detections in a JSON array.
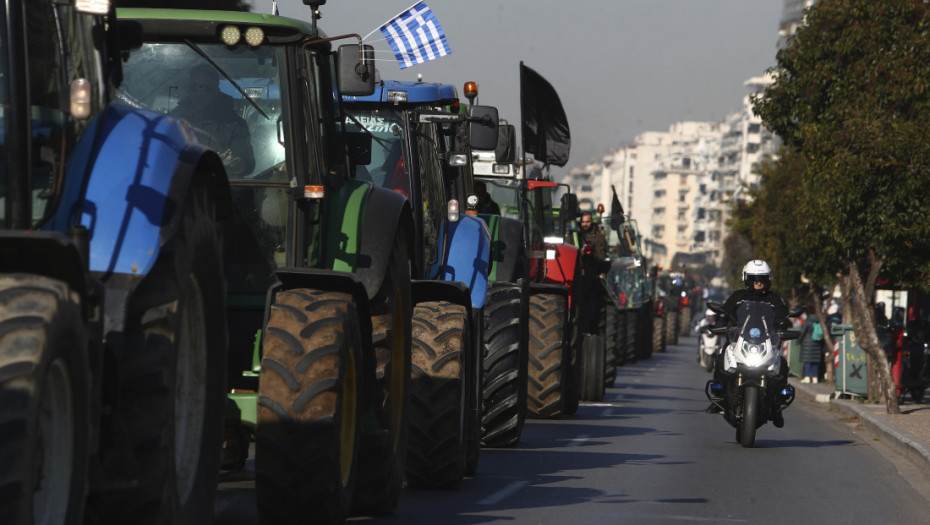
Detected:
[{"left": 119, "top": 6, "right": 417, "bottom": 523}]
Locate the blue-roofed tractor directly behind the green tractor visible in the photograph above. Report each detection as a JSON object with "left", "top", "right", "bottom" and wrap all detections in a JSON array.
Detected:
[{"left": 343, "top": 80, "right": 497, "bottom": 488}]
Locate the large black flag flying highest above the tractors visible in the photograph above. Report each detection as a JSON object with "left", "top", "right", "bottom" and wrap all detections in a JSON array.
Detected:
[{"left": 520, "top": 62, "right": 572, "bottom": 166}]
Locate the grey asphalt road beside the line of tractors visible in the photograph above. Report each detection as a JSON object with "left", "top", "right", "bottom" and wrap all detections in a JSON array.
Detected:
[{"left": 215, "top": 337, "right": 930, "bottom": 525}]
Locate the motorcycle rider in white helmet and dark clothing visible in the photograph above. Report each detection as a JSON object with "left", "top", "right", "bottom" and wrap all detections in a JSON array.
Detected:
[{"left": 707, "top": 259, "right": 791, "bottom": 428}]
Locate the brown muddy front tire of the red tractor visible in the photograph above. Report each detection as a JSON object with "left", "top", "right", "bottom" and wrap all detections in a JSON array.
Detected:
[{"left": 526, "top": 294, "right": 570, "bottom": 419}]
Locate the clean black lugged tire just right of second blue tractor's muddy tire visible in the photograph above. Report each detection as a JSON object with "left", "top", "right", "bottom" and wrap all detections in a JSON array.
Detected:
[{"left": 481, "top": 282, "right": 527, "bottom": 447}]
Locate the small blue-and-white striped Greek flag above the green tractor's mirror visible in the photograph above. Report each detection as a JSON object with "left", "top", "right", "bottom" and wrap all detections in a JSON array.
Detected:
[{"left": 381, "top": 2, "right": 452, "bottom": 69}]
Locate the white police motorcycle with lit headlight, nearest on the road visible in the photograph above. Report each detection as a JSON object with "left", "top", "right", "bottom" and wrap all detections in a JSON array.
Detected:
[{"left": 704, "top": 302, "right": 803, "bottom": 448}]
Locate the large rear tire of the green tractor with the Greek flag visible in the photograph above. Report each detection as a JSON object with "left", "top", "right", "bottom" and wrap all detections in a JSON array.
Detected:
[{"left": 352, "top": 234, "right": 413, "bottom": 516}]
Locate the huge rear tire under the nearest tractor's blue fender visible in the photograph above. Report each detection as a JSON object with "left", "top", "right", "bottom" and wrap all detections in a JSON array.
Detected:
[{"left": 96, "top": 182, "right": 227, "bottom": 524}]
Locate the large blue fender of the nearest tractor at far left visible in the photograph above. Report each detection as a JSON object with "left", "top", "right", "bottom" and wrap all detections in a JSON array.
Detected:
[{"left": 45, "top": 105, "right": 229, "bottom": 276}]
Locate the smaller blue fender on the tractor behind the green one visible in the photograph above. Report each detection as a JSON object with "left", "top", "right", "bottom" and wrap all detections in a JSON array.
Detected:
[{"left": 430, "top": 215, "right": 491, "bottom": 308}]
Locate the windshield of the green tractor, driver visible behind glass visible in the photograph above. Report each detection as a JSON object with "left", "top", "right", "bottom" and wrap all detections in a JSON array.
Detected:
[{"left": 117, "top": 43, "right": 288, "bottom": 181}]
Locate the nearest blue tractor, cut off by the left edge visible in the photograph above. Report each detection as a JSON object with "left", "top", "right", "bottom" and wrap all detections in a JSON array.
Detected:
[{"left": 0, "top": 0, "right": 230, "bottom": 524}]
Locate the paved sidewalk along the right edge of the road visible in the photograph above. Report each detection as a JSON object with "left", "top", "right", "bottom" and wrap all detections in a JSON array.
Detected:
[{"left": 789, "top": 377, "right": 930, "bottom": 472}]
